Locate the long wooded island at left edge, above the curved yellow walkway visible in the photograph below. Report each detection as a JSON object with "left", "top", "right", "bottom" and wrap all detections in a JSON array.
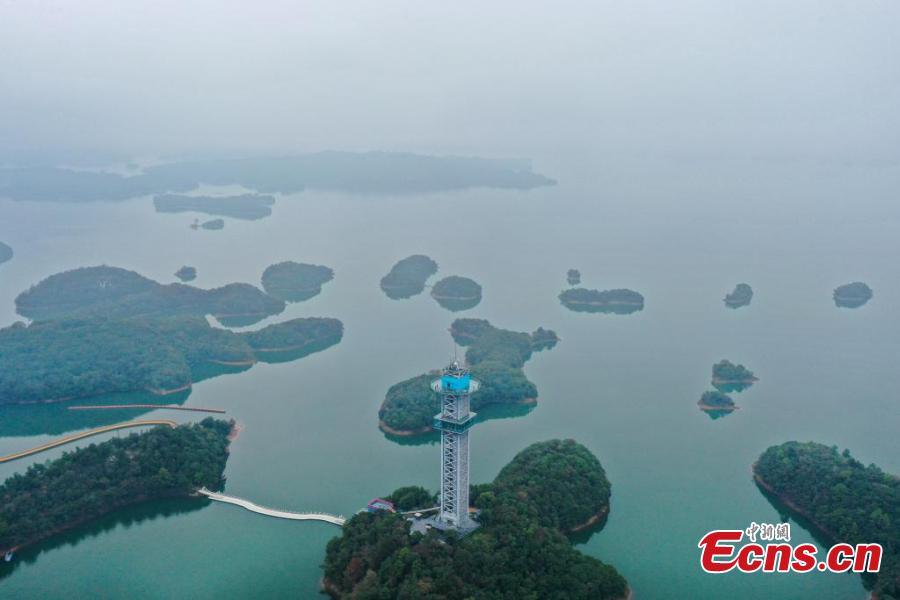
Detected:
[{"left": 0, "top": 316, "right": 343, "bottom": 404}]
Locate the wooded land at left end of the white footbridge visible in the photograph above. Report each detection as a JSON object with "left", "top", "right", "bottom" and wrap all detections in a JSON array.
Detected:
[{"left": 0, "top": 418, "right": 234, "bottom": 555}]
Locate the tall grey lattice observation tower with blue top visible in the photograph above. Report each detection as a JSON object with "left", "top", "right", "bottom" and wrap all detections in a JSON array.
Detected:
[{"left": 431, "top": 361, "right": 479, "bottom": 534}]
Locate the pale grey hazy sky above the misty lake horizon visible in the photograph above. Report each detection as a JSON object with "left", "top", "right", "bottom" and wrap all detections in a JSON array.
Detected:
[{"left": 0, "top": 0, "right": 900, "bottom": 163}]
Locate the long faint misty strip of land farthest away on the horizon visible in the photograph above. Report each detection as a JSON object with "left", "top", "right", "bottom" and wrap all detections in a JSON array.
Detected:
[{"left": 0, "top": 152, "right": 556, "bottom": 202}]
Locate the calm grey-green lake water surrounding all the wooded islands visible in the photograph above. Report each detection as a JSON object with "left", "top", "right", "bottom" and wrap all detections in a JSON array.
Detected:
[{"left": 0, "top": 158, "right": 900, "bottom": 600}]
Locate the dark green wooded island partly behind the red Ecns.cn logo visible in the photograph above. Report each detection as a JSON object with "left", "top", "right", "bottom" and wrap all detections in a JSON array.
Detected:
[{"left": 753, "top": 442, "right": 900, "bottom": 600}]
